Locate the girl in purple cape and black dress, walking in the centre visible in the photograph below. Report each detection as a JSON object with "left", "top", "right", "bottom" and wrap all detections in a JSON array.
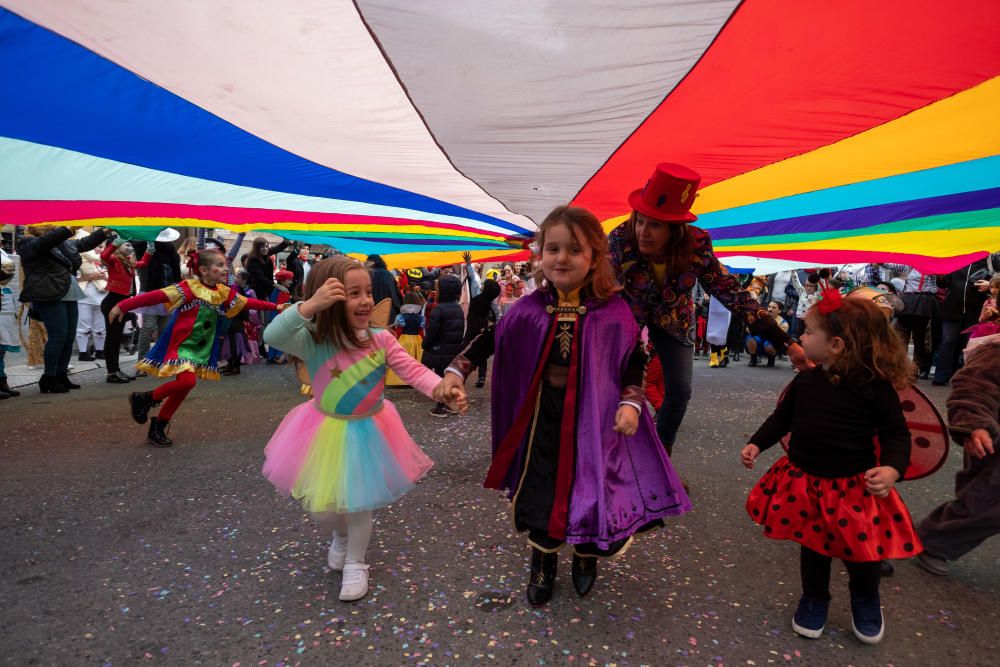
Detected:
[{"left": 442, "top": 206, "right": 691, "bottom": 606}]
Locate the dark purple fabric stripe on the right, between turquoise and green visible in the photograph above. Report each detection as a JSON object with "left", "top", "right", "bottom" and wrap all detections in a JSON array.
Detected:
[{"left": 705, "top": 188, "right": 1000, "bottom": 240}]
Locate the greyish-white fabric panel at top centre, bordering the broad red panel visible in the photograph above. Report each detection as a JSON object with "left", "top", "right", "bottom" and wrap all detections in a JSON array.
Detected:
[{"left": 358, "top": 0, "right": 738, "bottom": 221}]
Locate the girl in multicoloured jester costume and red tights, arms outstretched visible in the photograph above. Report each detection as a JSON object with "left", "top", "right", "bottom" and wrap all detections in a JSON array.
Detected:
[{"left": 108, "top": 250, "right": 277, "bottom": 447}]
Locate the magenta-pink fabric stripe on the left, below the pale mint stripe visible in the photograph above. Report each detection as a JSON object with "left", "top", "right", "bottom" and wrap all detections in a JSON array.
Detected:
[{"left": 0, "top": 200, "right": 503, "bottom": 238}]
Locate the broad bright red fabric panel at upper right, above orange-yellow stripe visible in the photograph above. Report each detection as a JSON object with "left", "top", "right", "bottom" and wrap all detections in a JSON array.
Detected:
[{"left": 573, "top": 0, "right": 1000, "bottom": 219}]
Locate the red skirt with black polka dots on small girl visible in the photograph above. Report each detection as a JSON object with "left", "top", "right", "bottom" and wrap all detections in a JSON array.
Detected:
[{"left": 747, "top": 456, "right": 924, "bottom": 562}]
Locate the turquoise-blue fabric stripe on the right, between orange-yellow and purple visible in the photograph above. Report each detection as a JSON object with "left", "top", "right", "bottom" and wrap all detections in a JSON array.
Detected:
[{"left": 697, "top": 156, "right": 1000, "bottom": 230}]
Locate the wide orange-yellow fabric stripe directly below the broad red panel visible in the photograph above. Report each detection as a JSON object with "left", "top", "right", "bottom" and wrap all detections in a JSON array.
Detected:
[{"left": 693, "top": 76, "right": 1000, "bottom": 214}]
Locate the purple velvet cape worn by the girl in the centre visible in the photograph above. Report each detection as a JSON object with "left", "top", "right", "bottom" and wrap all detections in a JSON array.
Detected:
[{"left": 492, "top": 290, "right": 691, "bottom": 549}]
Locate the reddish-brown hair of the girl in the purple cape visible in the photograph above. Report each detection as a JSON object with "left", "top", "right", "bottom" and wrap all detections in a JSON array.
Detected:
[{"left": 532, "top": 206, "right": 621, "bottom": 301}]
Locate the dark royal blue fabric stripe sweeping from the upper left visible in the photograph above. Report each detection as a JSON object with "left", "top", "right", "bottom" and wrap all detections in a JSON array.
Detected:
[{"left": 0, "top": 8, "right": 526, "bottom": 233}]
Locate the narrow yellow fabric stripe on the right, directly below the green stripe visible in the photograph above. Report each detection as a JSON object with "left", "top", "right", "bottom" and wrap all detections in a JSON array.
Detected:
[{"left": 716, "top": 227, "right": 1000, "bottom": 257}]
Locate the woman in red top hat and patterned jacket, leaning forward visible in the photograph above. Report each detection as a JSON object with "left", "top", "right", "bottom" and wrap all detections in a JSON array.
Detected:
[{"left": 608, "top": 163, "right": 805, "bottom": 462}]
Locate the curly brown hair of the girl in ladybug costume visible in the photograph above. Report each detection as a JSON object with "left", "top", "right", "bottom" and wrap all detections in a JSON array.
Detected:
[{"left": 806, "top": 299, "right": 914, "bottom": 389}]
